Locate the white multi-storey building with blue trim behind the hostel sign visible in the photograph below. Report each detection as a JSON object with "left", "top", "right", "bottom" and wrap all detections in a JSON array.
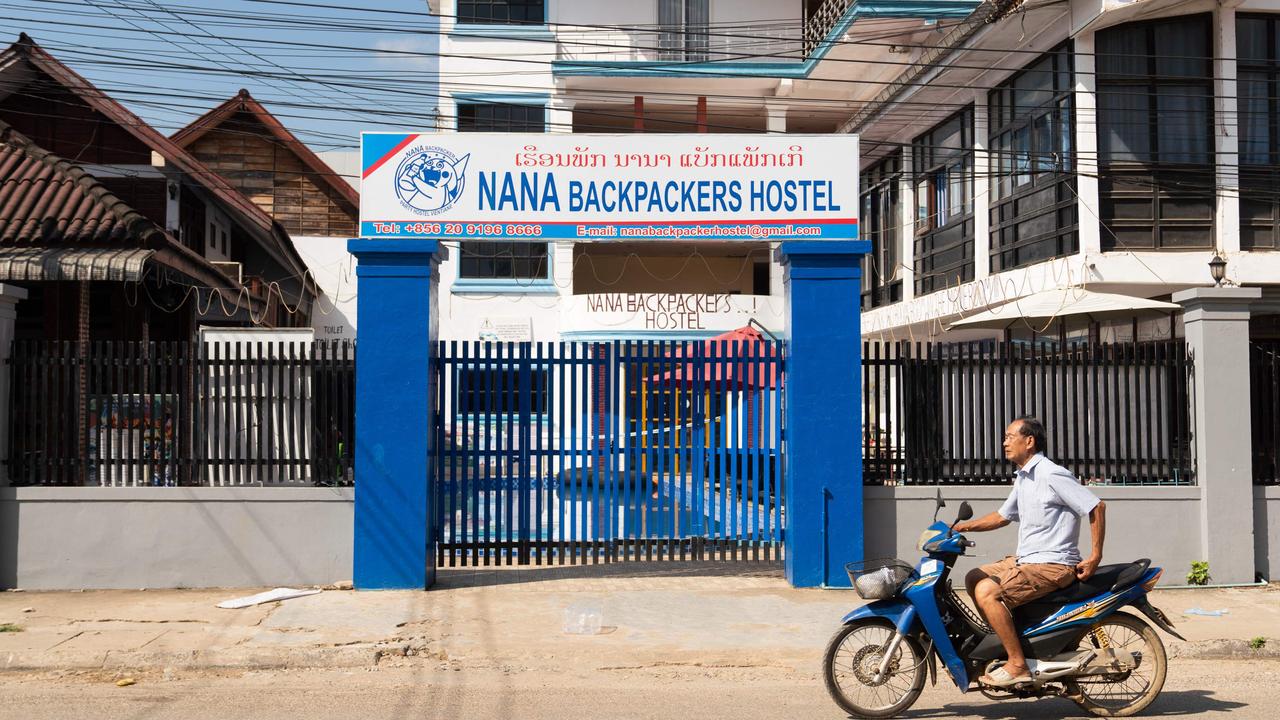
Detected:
[{"left": 429, "top": 0, "right": 1280, "bottom": 340}]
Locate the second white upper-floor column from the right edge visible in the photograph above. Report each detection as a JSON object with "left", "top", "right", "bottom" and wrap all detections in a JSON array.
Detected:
[{"left": 1075, "top": 32, "right": 1102, "bottom": 255}]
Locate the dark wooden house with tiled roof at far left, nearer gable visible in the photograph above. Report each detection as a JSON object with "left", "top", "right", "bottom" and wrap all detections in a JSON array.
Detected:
[{"left": 0, "top": 35, "right": 316, "bottom": 342}]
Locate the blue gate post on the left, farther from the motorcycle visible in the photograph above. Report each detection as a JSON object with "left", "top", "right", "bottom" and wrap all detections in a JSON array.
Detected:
[{"left": 347, "top": 240, "right": 440, "bottom": 589}]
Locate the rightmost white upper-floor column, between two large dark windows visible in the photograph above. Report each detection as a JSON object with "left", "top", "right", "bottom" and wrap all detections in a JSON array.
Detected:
[{"left": 1213, "top": 8, "right": 1240, "bottom": 254}]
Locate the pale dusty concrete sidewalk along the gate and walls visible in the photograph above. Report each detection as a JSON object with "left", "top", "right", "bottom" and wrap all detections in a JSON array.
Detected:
[{"left": 0, "top": 564, "right": 1280, "bottom": 673}]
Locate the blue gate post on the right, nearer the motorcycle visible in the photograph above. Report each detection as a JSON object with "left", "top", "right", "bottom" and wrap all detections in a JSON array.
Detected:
[{"left": 778, "top": 241, "right": 870, "bottom": 588}]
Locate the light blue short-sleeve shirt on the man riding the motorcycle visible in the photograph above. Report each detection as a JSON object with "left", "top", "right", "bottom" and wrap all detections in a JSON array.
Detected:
[{"left": 1000, "top": 454, "right": 1098, "bottom": 565}]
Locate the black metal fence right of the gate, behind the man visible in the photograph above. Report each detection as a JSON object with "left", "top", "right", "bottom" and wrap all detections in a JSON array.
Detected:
[{"left": 861, "top": 341, "right": 1198, "bottom": 486}]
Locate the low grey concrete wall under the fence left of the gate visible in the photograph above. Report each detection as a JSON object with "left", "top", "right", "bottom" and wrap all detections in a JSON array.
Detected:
[{"left": 0, "top": 487, "right": 355, "bottom": 589}]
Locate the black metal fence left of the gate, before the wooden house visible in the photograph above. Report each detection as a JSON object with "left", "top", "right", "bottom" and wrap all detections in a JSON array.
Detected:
[{"left": 8, "top": 341, "right": 356, "bottom": 486}]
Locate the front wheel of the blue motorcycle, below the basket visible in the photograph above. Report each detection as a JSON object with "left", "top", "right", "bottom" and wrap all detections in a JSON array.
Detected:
[{"left": 822, "top": 619, "right": 925, "bottom": 717}]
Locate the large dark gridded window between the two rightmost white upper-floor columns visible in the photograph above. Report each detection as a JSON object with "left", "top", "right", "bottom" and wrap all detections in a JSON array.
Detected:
[{"left": 1096, "top": 14, "right": 1215, "bottom": 250}]
